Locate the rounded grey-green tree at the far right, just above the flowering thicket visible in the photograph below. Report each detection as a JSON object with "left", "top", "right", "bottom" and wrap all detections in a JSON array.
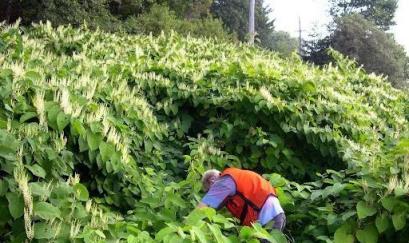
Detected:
[{"left": 306, "top": 14, "right": 408, "bottom": 88}]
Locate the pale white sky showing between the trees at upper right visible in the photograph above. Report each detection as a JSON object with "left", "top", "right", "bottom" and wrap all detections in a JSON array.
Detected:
[{"left": 265, "top": 0, "right": 409, "bottom": 54}]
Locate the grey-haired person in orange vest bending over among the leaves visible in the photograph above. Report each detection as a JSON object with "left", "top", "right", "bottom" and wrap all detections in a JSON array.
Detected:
[{"left": 197, "top": 168, "right": 286, "bottom": 235}]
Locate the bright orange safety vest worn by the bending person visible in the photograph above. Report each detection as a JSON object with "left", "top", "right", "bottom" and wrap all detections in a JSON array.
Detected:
[{"left": 221, "top": 168, "right": 277, "bottom": 226}]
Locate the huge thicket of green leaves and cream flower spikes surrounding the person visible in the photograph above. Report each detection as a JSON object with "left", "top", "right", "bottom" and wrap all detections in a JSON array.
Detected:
[{"left": 0, "top": 23, "right": 409, "bottom": 243}]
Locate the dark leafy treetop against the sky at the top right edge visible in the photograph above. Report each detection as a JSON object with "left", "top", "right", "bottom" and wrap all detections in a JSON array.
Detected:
[{"left": 330, "top": 0, "right": 398, "bottom": 30}]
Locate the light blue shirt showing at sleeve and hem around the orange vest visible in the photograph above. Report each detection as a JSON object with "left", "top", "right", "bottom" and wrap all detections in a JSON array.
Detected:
[{"left": 202, "top": 176, "right": 284, "bottom": 225}]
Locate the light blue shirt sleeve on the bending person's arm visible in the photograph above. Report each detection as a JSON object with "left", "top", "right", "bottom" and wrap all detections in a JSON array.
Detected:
[{"left": 202, "top": 176, "right": 236, "bottom": 208}]
